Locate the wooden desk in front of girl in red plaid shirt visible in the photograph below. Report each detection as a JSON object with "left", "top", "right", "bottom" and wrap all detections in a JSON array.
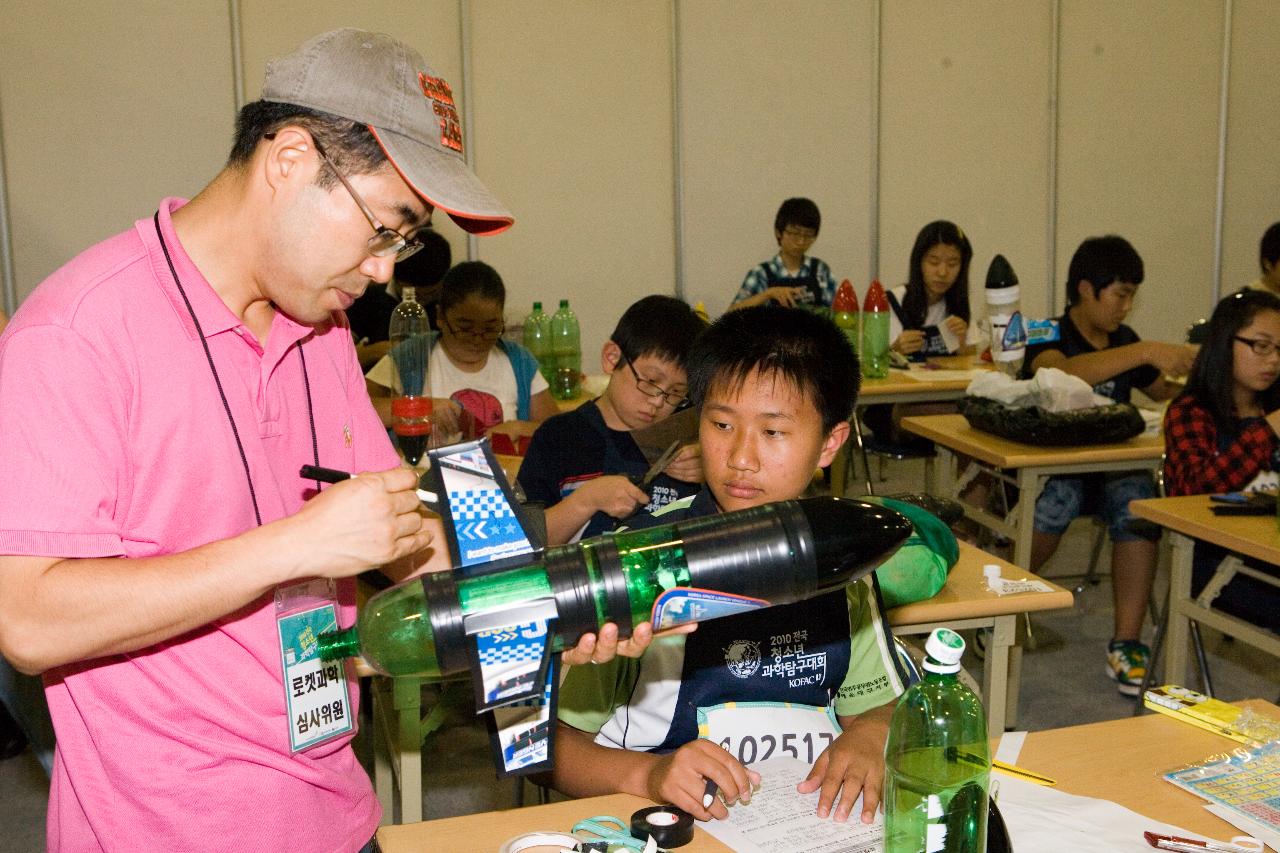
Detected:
[{"left": 1129, "top": 494, "right": 1280, "bottom": 684}]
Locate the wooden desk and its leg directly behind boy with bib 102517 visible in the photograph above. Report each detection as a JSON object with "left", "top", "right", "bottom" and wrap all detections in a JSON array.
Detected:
[{"left": 887, "top": 542, "right": 1074, "bottom": 733}]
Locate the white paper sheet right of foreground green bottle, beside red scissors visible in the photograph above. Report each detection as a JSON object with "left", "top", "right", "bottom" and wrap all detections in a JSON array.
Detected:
[{"left": 992, "top": 774, "right": 1199, "bottom": 853}]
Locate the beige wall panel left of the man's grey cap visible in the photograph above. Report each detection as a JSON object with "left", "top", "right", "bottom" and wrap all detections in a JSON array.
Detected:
[{"left": 0, "top": 0, "right": 233, "bottom": 300}]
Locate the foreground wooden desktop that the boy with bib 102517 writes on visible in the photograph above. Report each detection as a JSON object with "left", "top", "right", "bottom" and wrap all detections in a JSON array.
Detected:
[{"left": 378, "top": 699, "right": 1280, "bottom": 853}]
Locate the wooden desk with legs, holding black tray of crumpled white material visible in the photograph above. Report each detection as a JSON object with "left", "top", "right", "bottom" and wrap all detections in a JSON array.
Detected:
[{"left": 902, "top": 415, "right": 1165, "bottom": 566}]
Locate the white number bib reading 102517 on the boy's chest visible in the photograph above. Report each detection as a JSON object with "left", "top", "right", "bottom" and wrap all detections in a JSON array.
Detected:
[{"left": 698, "top": 702, "right": 840, "bottom": 765}]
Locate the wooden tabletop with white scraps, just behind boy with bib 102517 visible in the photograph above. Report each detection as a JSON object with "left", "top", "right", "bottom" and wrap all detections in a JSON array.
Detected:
[{"left": 887, "top": 542, "right": 1074, "bottom": 625}]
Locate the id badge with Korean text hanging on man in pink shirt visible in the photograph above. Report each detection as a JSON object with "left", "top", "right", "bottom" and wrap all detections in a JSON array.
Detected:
[{"left": 275, "top": 579, "right": 355, "bottom": 753}]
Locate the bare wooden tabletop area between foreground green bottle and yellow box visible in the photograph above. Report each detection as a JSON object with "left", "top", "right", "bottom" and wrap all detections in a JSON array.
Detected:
[{"left": 1008, "top": 699, "right": 1280, "bottom": 839}]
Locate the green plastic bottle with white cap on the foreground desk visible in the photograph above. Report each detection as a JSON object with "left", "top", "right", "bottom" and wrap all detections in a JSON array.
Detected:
[{"left": 884, "top": 628, "right": 991, "bottom": 853}]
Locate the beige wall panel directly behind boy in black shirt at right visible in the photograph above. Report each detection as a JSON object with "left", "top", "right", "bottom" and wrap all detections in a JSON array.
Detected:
[{"left": 1057, "top": 0, "right": 1222, "bottom": 339}]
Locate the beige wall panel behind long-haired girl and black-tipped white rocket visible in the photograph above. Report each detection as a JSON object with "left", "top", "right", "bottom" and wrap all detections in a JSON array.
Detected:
[{"left": 879, "top": 0, "right": 1052, "bottom": 325}]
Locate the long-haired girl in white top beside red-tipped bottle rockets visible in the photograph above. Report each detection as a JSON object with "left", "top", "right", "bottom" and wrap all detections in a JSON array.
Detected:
[{"left": 886, "top": 219, "right": 973, "bottom": 360}]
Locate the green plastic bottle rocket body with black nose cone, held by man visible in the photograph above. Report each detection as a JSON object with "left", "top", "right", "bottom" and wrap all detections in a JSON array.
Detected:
[{"left": 319, "top": 498, "right": 911, "bottom": 678}]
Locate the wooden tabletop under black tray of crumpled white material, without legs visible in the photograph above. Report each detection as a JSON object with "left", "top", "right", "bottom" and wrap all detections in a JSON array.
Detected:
[{"left": 902, "top": 415, "right": 1165, "bottom": 467}]
